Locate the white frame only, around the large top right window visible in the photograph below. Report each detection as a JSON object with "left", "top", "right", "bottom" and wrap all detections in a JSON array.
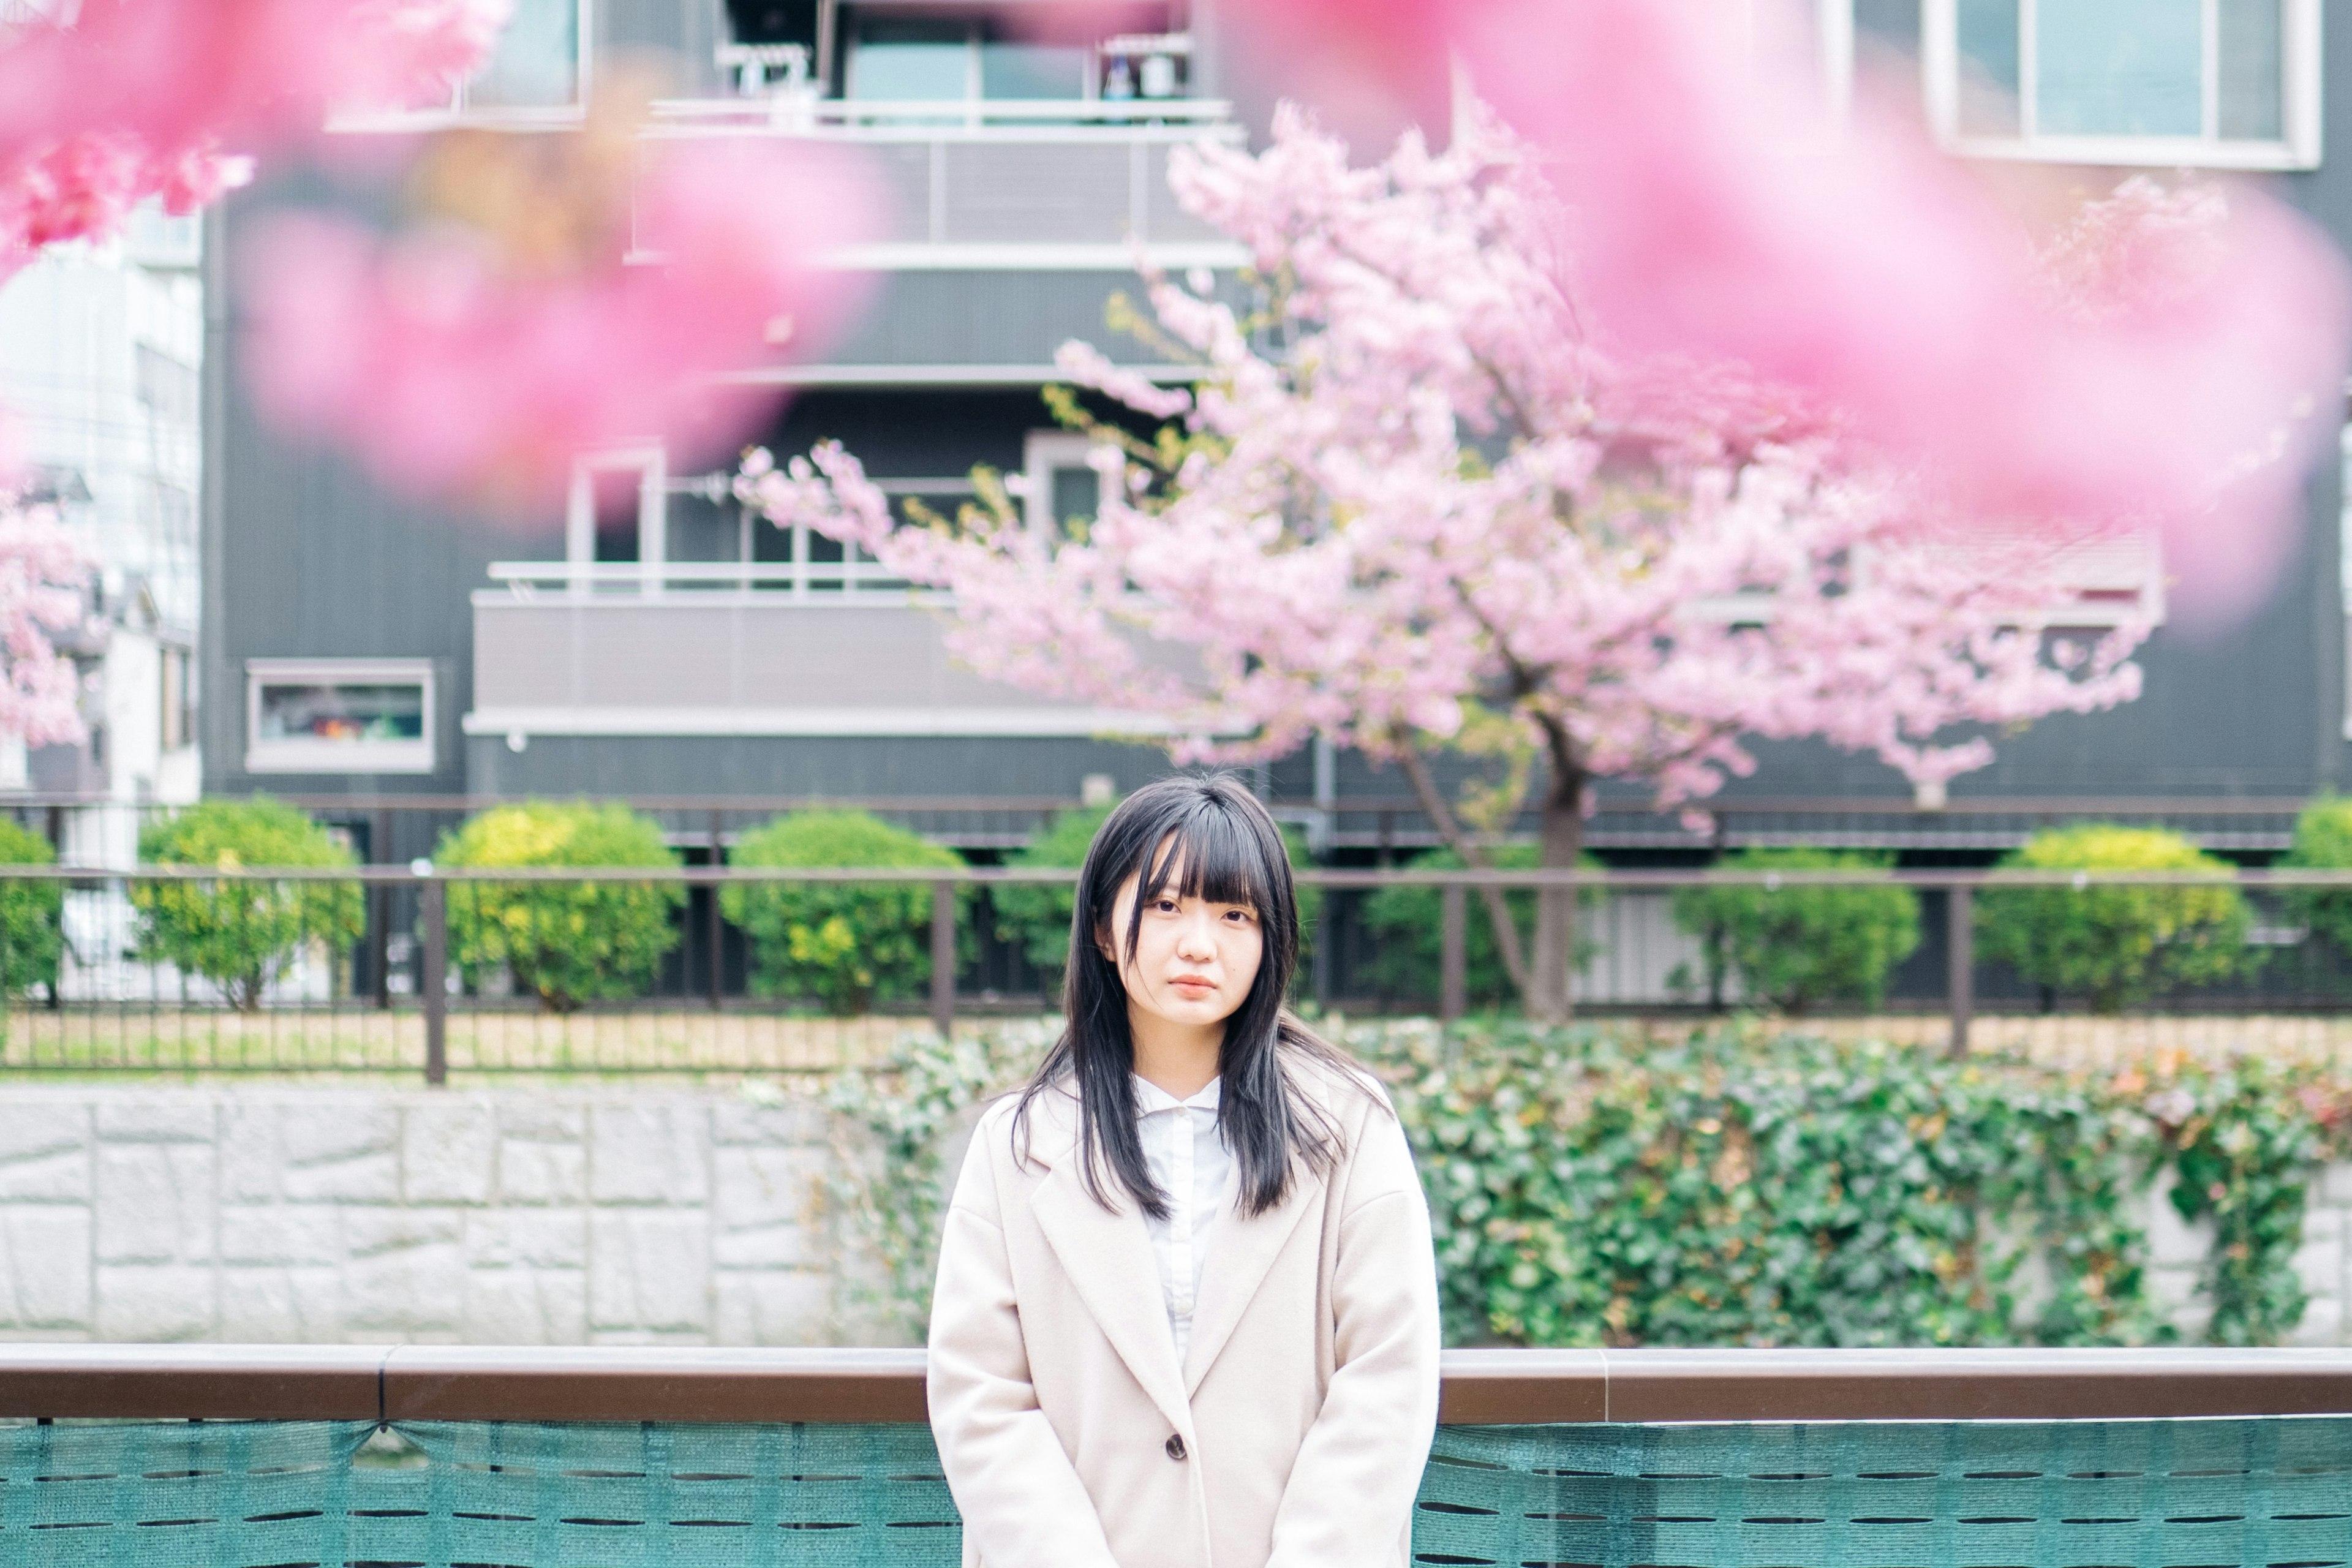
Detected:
[{"left": 1919, "top": 0, "right": 2326, "bottom": 169}]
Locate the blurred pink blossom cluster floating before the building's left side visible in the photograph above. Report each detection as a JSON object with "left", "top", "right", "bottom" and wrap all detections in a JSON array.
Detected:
[{"left": 238, "top": 141, "right": 877, "bottom": 508}]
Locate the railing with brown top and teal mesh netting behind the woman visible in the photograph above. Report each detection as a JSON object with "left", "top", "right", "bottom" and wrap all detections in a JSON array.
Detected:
[{"left": 0, "top": 1344, "right": 2352, "bottom": 1568}]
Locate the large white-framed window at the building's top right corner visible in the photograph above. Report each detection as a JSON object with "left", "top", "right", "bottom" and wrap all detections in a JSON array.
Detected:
[{"left": 1924, "top": 0, "right": 2319, "bottom": 169}]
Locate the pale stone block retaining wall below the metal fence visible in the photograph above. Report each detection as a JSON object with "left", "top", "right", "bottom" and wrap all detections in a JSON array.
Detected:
[{"left": 0, "top": 1084, "right": 2352, "bottom": 1344}]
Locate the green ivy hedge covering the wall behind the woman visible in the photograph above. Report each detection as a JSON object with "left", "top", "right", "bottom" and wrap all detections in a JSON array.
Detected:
[{"left": 831, "top": 1020, "right": 2352, "bottom": 1344}]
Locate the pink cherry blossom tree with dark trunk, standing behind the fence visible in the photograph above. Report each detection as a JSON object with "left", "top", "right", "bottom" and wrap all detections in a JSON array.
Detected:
[{"left": 739, "top": 113, "right": 2218, "bottom": 1016}]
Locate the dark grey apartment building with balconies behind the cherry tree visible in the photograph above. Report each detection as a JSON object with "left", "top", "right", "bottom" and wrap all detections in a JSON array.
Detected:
[{"left": 202, "top": 0, "right": 2352, "bottom": 853}]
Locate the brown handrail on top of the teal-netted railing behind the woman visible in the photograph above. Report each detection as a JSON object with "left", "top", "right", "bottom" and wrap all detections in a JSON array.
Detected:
[{"left": 0, "top": 1344, "right": 2352, "bottom": 1425}]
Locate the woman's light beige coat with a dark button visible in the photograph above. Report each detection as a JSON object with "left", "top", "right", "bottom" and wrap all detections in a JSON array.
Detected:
[{"left": 929, "top": 1065, "right": 1437, "bottom": 1568}]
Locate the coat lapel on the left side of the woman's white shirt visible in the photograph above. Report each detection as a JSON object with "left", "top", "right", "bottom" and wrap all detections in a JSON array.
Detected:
[{"left": 1030, "top": 1091, "right": 1193, "bottom": 1431}]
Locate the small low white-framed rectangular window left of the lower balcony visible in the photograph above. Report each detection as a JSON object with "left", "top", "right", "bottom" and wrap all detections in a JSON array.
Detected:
[{"left": 244, "top": 658, "right": 433, "bottom": 774}]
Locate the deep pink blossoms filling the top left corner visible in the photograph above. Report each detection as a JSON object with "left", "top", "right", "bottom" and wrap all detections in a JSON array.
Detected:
[{"left": 0, "top": 0, "right": 513, "bottom": 275}]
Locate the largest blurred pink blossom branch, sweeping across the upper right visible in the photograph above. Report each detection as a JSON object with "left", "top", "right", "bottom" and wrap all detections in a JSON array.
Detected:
[{"left": 1235, "top": 0, "right": 2352, "bottom": 618}]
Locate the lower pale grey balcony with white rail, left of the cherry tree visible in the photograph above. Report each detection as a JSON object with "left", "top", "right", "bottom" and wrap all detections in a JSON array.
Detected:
[{"left": 463, "top": 550, "right": 1166, "bottom": 738}]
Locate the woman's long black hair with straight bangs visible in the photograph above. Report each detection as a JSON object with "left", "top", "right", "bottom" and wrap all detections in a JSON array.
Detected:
[{"left": 1014, "top": 774, "right": 1362, "bottom": 1218}]
